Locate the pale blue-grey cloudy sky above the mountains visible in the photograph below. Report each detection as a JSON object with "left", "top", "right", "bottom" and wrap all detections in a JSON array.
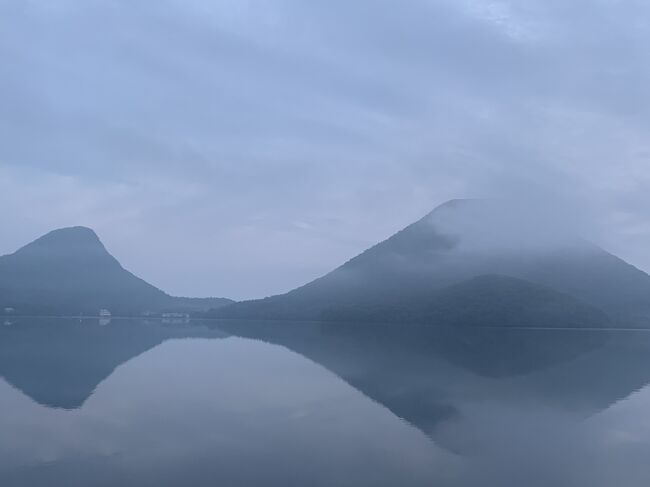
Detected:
[{"left": 0, "top": 0, "right": 650, "bottom": 298}]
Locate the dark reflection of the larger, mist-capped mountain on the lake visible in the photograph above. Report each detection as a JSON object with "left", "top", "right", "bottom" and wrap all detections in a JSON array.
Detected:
[{"left": 220, "top": 322, "right": 650, "bottom": 450}]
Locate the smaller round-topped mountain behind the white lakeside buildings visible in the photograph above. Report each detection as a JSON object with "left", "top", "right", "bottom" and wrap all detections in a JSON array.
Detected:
[{"left": 0, "top": 227, "right": 232, "bottom": 315}]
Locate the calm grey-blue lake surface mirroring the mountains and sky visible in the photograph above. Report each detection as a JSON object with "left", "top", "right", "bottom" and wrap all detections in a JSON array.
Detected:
[{"left": 0, "top": 318, "right": 650, "bottom": 487}]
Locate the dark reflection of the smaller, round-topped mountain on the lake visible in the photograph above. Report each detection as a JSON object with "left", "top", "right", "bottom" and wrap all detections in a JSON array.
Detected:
[{"left": 0, "top": 318, "right": 226, "bottom": 409}]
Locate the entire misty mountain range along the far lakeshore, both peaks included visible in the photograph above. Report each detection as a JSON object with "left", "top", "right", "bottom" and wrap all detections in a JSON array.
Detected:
[{"left": 6, "top": 200, "right": 650, "bottom": 327}]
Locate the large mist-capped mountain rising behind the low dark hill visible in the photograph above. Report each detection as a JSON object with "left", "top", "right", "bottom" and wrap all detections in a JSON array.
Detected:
[{"left": 212, "top": 200, "right": 650, "bottom": 326}]
